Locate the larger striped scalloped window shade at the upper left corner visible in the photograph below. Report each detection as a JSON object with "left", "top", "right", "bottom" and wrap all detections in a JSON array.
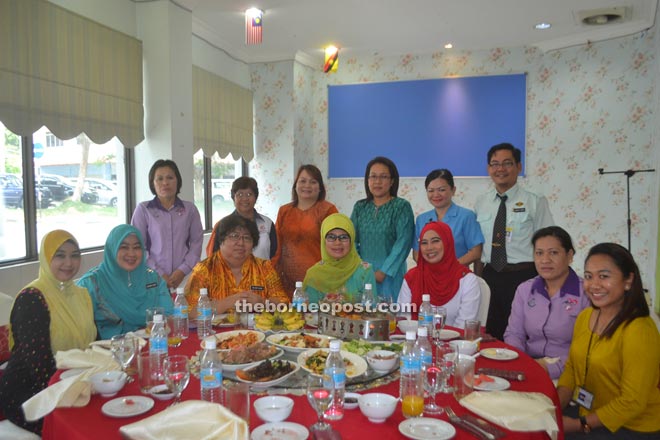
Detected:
[{"left": 0, "top": 0, "right": 144, "bottom": 147}]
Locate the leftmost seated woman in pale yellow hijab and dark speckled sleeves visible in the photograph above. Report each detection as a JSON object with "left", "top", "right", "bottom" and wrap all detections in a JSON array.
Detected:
[{"left": 0, "top": 229, "right": 96, "bottom": 433}]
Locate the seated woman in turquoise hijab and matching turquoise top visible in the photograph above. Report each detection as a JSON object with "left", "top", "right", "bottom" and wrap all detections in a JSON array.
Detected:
[{"left": 78, "top": 225, "right": 173, "bottom": 339}]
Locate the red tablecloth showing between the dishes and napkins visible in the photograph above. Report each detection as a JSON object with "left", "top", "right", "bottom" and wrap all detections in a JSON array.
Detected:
[{"left": 42, "top": 328, "right": 563, "bottom": 440}]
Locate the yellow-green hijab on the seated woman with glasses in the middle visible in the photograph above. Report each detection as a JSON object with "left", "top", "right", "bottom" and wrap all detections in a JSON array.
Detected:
[{"left": 303, "top": 213, "right": 362, "bottom": 293}]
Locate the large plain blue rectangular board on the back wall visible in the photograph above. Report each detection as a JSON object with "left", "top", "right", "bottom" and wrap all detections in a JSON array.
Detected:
[{"left": 328, "top": 74, "right": 526, "bottom": 178}]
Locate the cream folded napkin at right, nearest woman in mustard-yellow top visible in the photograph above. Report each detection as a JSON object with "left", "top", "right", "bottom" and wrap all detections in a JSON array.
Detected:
[{"left": 459, "top": 391, "right": 559, "bottom": 440}]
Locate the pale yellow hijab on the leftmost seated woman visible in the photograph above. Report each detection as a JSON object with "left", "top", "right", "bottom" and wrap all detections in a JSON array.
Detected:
[{"left": 25, "top": 229, "right": 96, "bottom": 353}]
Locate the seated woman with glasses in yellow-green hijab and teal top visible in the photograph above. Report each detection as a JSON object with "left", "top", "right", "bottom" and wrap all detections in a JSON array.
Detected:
[{"left": 303, "top": 214, "right": 376, "bottom": 303}]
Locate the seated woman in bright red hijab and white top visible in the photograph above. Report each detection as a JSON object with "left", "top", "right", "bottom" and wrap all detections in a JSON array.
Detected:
[{"left": 399, "top": 222, "right": 481, "bottom": 328}]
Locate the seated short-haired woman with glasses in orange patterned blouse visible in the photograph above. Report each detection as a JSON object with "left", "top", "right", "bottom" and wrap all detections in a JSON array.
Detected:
[{"left": 186, "top": 214, "right": 288, "bottom": 313}]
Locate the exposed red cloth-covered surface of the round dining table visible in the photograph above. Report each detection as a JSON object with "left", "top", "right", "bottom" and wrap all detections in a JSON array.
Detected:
[{"left": 42, "top": 327, "right": 563, "bottom": 440}]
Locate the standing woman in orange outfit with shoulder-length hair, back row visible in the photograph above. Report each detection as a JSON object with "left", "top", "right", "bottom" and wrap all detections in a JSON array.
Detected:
[{"left": 271, "top": 165, "right": 338, "bottom": 296}]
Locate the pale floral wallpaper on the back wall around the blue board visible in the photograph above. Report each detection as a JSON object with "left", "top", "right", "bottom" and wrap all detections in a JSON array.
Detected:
[{"left": 250, "top": 31, "right": 658, "bottom": 302}]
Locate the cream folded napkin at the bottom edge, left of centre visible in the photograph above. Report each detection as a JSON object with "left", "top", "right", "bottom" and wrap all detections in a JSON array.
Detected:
[{"left": 119, "top": 400, "right": 250, "bottom": 440}]
